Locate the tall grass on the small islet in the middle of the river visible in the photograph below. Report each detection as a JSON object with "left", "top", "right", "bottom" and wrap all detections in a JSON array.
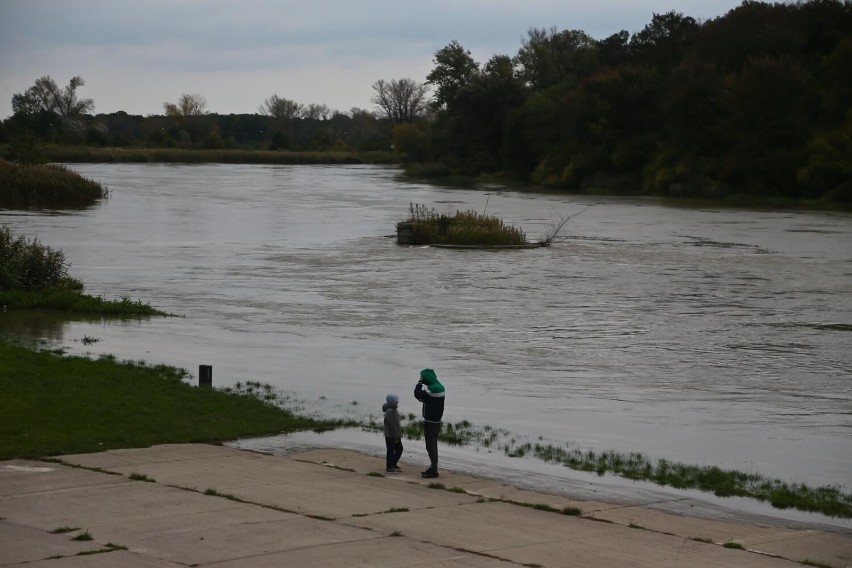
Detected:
[{"left": 404, "top": 203, "right": 527, "bottom": 246}]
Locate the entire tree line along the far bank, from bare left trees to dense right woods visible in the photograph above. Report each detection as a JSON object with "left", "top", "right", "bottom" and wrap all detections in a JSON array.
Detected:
[{"left": 0, "top": 0, "right": 852, "bottom": 203}]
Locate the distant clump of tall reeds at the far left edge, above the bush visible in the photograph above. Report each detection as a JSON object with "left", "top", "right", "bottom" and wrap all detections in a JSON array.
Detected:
[{"left": 0, "top": 158, "right": 108, "bottom": 209}]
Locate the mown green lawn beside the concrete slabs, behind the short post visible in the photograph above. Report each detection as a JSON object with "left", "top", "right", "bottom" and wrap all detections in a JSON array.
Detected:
[{"left": 0, "top": 342, "right": 337, "bottom": 459}]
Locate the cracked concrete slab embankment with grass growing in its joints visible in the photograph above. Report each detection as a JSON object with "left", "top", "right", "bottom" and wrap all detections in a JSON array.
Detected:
[{"left": 0, "top": 444, "right": 852, "bottom": 568}]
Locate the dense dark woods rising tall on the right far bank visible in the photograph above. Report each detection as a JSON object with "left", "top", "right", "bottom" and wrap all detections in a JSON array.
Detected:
[{"left": 412, "top": 0, "right": 852, "bottom": 203}]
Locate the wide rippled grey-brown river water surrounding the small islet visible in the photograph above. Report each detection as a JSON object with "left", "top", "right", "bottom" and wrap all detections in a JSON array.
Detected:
[{"left": 0, "top": 164, "right": 852, "bottom": 528}]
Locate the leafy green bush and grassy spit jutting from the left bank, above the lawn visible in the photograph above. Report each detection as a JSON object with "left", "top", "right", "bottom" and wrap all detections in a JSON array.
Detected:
[{"left": 0, "top": 227, "right": 169, "bottom": 316}]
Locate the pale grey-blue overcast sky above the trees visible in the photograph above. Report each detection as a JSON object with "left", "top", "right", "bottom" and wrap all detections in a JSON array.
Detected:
[{"left": 0, "top": 0, "right": 741, "bottom": 119}]
